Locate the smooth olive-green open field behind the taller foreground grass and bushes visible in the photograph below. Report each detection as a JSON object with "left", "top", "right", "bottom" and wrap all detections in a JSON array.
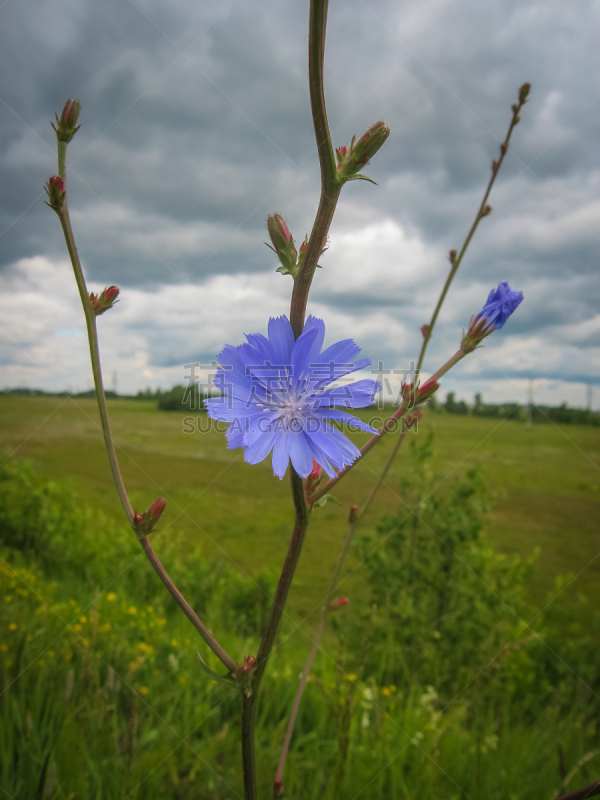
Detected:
[{"left": 0, "top": 396, "right": 600, "bottom": 615}]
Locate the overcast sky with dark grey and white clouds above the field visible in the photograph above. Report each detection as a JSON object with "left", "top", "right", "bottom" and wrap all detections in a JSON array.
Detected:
[{"left": 0, "top": 0, "right": 600, "bottom": 407}]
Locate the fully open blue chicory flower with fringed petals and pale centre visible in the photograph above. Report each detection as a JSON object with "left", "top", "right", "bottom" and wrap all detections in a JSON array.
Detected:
[{"left": 205, "top": 317, "right": 381, "bottom": 478}]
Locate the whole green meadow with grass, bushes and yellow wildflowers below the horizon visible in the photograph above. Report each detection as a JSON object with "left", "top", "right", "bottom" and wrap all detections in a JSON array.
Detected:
[{"left": 0, "top": 396, "right": 600, "bottom": 800}]
